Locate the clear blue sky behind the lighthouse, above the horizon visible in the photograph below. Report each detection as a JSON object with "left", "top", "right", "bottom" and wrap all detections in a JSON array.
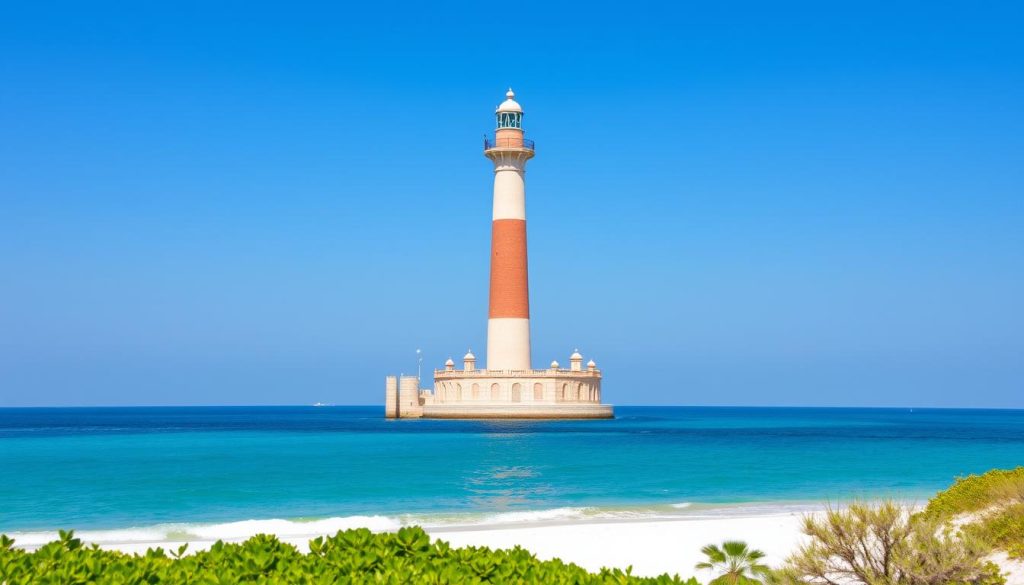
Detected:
[{"left": 0, "top": 1, "right": 1024, "bottom": 408}]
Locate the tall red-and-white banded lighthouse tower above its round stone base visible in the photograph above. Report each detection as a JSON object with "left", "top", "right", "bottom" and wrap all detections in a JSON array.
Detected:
[{"left": 483, "top": 88, "right": 534, "bottom": 370}]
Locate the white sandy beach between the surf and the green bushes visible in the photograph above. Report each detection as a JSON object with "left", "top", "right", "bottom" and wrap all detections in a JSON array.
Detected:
[{"left": 15, "top": 506, "right": 1024, "bottom": 585}]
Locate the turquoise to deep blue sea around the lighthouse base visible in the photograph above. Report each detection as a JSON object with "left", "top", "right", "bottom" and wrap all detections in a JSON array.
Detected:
[{"left": 0, "top": 407, "right": 1024, "bottom": 545}]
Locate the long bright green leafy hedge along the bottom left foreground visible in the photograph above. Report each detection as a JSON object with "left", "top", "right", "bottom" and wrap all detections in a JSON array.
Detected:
[{"left": 0, "top": 528, "right": 699, "bottom": 585}]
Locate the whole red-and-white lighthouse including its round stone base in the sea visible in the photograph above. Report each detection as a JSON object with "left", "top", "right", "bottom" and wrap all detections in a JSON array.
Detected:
[{"left": 384, "top": 89, "right": 614, "bottom": 419}]
